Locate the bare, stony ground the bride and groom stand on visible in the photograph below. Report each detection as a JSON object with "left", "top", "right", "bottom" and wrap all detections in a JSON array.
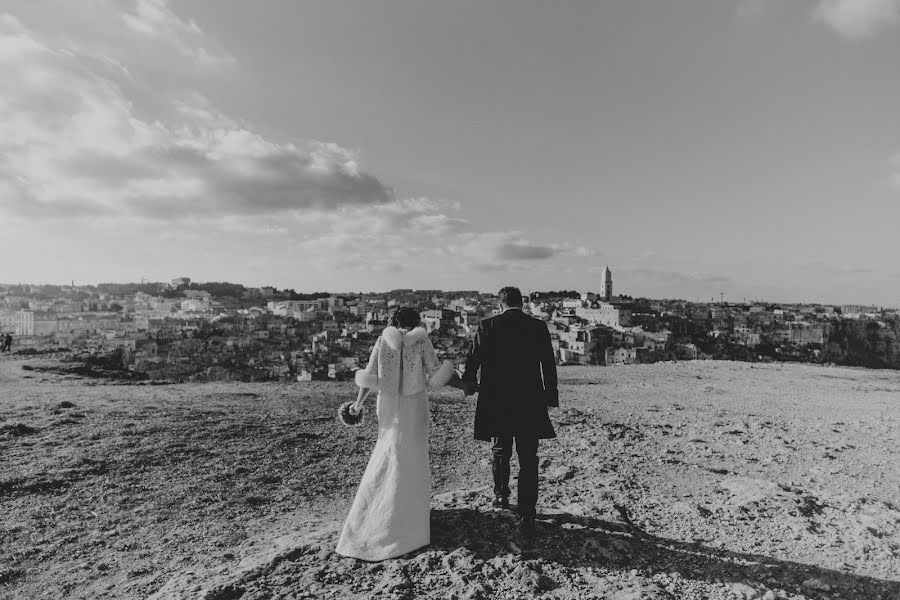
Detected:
[{"left": 0, "top": 358, "right": 900, "bottom": 600}]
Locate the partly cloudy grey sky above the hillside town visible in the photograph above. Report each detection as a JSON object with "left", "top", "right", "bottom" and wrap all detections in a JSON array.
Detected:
[{"left": 0, "top": 0, "right": 900, "bottom": 306}]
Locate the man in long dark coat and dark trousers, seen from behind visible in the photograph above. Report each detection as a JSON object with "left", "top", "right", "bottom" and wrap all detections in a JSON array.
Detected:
[{"left": 462, "top": 287, "right": 559, "bottom": 537}]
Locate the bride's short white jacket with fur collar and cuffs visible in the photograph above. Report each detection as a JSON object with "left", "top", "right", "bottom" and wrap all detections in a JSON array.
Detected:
[{"left": 356, "top": 327, "right": 455, "bottom": 396}]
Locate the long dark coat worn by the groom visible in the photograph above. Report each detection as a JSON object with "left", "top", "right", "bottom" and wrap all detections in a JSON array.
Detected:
[{"left": 463, "top": 309, "right": 559, "bottom": 441}]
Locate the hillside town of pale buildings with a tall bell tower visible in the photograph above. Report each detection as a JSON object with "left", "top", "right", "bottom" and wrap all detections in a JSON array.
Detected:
[{"left": 0, "top": 267, "right": 900, "bottom": 381}]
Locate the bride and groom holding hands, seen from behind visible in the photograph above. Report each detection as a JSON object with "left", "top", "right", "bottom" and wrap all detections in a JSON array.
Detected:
[{"left": 337, "top": 287, "right": 559, "bottom": 561}]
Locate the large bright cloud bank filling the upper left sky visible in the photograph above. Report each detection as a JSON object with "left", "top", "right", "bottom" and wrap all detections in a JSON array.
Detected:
[{"left": 0, "top": 0, "right": 599, "bottom": 290}]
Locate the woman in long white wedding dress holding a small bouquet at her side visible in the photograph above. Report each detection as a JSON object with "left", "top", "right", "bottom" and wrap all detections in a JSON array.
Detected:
[{"left": 337, "top": 308, "right": 459, "bottom": 561}]
